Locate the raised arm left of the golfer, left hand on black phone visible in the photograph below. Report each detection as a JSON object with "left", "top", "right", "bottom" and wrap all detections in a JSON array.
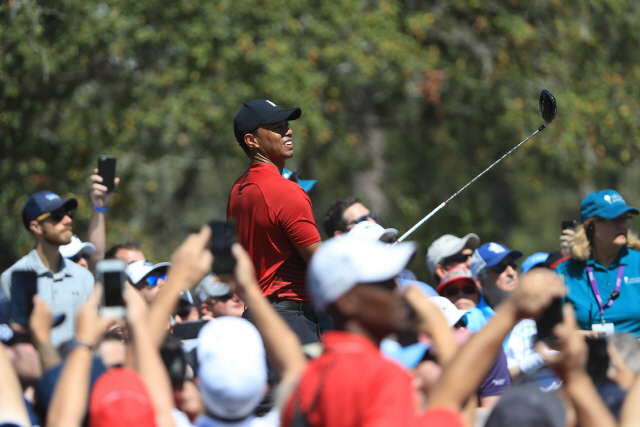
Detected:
[{"left": 148, "top": 226, "right": 213, "bottom": 348}]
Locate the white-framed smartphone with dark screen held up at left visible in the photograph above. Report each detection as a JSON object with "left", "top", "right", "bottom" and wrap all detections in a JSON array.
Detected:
[{"left": 96, "top": 259, "right": 126, "bottom": 317}]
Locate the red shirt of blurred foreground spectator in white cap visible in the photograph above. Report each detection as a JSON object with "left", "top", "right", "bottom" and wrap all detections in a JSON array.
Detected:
[{"left": 282, "top": 331, "right": 466, "bottom": 427}]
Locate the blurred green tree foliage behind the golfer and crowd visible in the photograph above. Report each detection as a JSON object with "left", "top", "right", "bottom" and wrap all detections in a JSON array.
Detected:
[{"left": 0, "top": 0, "right": 640, "bottom": 278}]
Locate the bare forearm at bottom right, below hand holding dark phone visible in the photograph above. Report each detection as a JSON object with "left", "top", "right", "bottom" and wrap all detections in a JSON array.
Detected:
[{"left": 563, "top": 372, "right": 616, "bottom": 427}]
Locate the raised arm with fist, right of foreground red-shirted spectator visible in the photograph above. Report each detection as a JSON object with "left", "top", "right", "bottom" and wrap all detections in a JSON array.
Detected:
[{"left": 429, "top": 269, "right": 565, "bottom": 410}]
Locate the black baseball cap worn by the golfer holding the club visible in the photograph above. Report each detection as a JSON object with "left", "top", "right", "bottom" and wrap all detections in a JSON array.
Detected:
[{"left": 233, "top": 99, "right": 302, "bottom": 143}]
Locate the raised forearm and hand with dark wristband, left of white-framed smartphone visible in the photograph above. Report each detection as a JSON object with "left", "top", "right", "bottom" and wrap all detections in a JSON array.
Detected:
[{"left": 47, "top": 285, "right": 113, "bottom": 427}]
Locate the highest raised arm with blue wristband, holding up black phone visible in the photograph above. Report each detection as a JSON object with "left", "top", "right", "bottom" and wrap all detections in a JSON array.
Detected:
[{"left": 87, "top": 169, "right": 120, "bottom": 273}]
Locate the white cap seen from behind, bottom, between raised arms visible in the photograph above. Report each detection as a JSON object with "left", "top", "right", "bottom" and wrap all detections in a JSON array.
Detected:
[{"left": 196, "top": 316, "right": 267, "bottom": 420}]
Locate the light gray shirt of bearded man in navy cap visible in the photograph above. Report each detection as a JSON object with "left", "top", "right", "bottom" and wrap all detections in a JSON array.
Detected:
[{"left": 0, "top": 249, "right": 95, "bottom": 347}]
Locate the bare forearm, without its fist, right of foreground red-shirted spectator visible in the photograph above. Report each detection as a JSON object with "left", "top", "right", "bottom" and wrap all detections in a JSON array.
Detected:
[{"left": 429, "top": 301, "right": 518, "bottom": 410}]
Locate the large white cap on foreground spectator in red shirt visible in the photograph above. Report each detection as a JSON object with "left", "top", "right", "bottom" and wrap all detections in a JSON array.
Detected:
[{"left": 307, "top": 238, "right": 416, "bottom": 310}]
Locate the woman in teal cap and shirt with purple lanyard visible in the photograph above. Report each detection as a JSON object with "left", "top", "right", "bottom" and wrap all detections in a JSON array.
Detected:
[{"left": 556, "top": 190, "right": 640, "bottom": 337}]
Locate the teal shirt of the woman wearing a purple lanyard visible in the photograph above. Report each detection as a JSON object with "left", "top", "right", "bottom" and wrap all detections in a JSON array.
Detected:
[{"left": 556, "top": 247, "right": 640, "bottom": 337}]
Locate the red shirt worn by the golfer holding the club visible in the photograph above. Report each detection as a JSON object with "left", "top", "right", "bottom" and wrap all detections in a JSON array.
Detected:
[{"left": 227, "top": 163, "right": 320, "bottom": 301}]
